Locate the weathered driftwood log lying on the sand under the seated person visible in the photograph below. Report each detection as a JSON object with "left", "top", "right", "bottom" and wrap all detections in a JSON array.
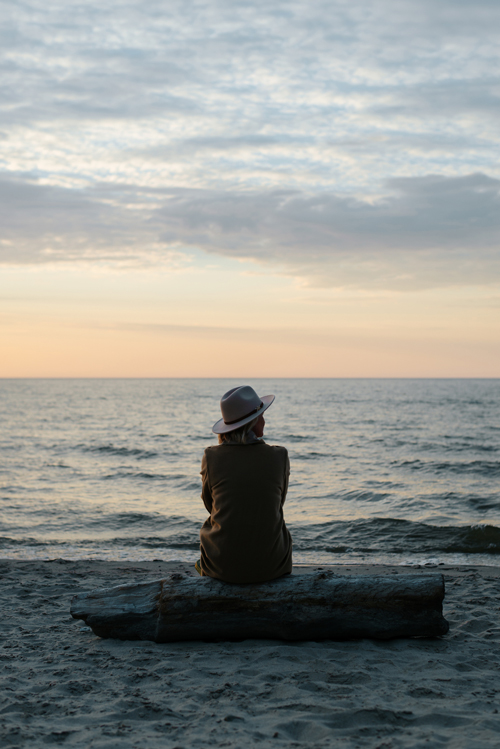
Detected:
[{"left": 71, "top": 572, "right": 448, "bottom": 642}]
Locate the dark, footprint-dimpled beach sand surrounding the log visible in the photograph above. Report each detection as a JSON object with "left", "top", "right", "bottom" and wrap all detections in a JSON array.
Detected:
[{"left": 0, "top": 560, "right": 500, "bottom": 749}]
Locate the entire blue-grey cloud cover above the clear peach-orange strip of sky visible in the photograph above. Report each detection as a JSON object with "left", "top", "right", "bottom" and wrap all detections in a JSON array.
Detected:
[{"left": 0, "top": 0, "right": 500, "bottom": 288}]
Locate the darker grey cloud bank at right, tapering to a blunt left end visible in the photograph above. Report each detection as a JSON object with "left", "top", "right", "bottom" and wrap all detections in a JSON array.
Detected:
[{"left": 157, "top": 174, "right": 500, "bottom": 288}]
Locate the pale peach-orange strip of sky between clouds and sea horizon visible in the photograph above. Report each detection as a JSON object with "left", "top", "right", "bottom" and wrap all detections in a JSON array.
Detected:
[{"left": 0, "top": 266, "right": 500, "bottom": 378}]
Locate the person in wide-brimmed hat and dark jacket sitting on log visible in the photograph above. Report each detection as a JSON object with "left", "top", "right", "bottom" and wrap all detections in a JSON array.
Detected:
[{"left": 195, "top": 385, "right": 292, "bottom": 583}]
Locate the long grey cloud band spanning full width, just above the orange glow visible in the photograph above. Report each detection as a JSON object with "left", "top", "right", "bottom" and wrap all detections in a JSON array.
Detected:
[{"left": 0, "top": 174, "right": 500, "bottom": 289}]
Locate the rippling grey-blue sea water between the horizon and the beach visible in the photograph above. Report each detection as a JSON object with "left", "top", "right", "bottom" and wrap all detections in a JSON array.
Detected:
[{"left": 0, "top": 379, "right": 500, "bottom": 564}]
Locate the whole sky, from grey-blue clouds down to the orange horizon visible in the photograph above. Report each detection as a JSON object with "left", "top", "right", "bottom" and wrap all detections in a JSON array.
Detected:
[{"left": 0, "top": 0, "right": 500, "bottom": 374}]
